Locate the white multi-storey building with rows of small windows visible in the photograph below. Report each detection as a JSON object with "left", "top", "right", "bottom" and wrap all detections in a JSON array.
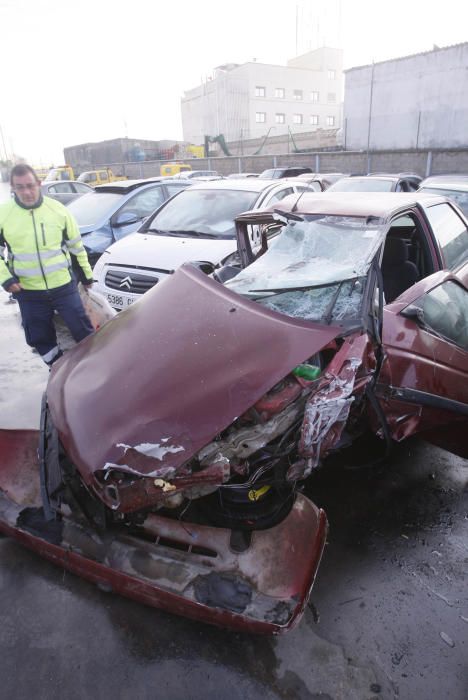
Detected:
[{"left": 181, "top": 47, "right": 343, "bottom": 144}]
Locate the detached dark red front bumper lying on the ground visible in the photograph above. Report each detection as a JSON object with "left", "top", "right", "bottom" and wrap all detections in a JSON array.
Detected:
[{"left": 0, "top": 430, "right": 327, "bottom": 634}]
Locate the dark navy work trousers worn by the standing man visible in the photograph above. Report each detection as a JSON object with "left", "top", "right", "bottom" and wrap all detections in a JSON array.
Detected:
[{"left": 14, "top": 280, "right": 94, "bottom": 364}]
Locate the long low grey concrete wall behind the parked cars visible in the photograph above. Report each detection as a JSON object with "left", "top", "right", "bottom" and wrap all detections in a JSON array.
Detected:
[{"left": 93, "top": 148, "right": 468, "bottom": 178}]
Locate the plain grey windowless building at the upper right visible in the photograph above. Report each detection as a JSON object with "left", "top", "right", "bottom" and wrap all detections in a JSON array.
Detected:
[{"left": 343, "top": 43, "right": 468, "bottom": 150}]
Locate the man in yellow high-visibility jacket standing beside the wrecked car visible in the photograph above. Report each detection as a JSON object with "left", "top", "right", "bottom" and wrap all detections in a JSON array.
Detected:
[{"left": 0, "top": 165, "right": 94, "bottom": 366}]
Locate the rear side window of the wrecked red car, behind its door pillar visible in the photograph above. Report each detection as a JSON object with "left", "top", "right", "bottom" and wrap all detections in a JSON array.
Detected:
[{"left": 426, "top": 204, "right": 468, "bottom": 268}]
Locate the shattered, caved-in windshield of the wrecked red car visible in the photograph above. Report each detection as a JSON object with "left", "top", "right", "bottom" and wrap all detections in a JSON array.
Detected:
[{"left": 226, "top": 215, "right": 385, "bottom": 323}]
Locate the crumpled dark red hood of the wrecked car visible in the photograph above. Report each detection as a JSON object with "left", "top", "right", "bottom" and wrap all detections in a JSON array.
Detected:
[{"left": 47, "top": 265, "right": 340, "bottom": 482}]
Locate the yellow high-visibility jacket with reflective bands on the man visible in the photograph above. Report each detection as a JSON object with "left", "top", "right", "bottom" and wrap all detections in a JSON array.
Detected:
[{"left": 0, "top": 197, "right": 93, "bottom": 291}]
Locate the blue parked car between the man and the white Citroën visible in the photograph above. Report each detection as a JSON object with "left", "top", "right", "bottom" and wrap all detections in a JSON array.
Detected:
[{"left": 69, "top": 177, "right": 190, "bottom": 264}]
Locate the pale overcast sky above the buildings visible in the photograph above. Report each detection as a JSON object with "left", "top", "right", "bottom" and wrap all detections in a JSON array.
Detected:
[{"left": 0, "top": 0, "right": 468, "bottom": 165}]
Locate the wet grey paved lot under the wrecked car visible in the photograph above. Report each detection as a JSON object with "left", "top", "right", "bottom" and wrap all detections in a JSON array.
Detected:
[{"left": 0, "top": 280, "right": 468, "bottom": 700}]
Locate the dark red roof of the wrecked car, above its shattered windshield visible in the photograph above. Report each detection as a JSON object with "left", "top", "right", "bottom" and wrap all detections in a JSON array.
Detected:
[{"left": 241, "top": 192, "right": 448, "bottom": 219}]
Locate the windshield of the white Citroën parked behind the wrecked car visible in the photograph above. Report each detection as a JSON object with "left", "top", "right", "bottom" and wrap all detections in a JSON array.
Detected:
[{"left": 146, "top": 189, "right": 258, "bottom": 238}]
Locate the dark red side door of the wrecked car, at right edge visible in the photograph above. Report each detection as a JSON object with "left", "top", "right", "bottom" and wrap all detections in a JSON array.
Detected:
[{"left": 377, "top": 271, "right": 468, "bottom": 457}]
